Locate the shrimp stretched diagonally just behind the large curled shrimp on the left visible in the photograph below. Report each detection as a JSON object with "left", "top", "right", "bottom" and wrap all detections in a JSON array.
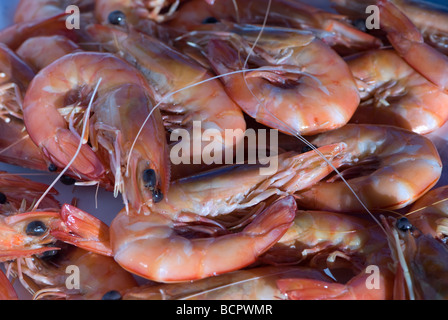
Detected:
[{"left": 87, "top": 25, "right": 246, "bottom": 159}]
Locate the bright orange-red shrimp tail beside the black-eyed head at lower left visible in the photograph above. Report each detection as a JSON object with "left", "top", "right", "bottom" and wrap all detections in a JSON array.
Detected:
[{"left": 51, "top": 204, "right": 112, "bottom": 256}]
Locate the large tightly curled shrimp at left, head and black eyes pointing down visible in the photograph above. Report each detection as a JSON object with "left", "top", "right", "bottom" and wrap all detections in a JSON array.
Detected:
[{"left": 23, "top": 52, "right": 169, "bottom": 210}]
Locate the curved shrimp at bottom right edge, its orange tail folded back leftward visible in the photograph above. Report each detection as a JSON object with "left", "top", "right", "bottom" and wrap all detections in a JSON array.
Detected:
[{"left": 268, "top": 210, "right": 395, "bottom": 300}]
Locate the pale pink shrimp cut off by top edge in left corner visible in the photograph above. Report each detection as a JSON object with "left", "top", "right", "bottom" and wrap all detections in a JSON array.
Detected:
[{"left": 14, "top": 0, "right": 94, "bottom": 23}]
